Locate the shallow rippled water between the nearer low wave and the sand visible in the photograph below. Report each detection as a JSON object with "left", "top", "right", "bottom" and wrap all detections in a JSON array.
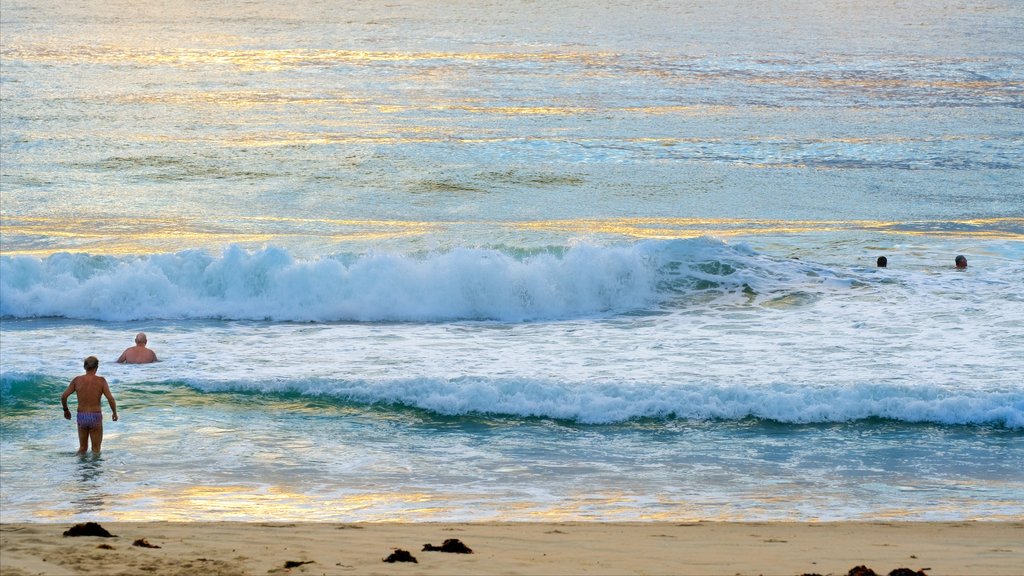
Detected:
[{"left": 3, "top": 385, "right": 1024, "bottom": 522}]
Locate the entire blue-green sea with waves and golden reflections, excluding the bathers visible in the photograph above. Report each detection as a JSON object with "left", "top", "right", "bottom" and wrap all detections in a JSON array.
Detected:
[{"left": 0, "top": 0, "right": 1024, "bottom": 522}]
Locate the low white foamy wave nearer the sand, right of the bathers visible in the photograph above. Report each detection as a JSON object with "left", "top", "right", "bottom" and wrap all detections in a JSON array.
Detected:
[{"left": 184, "top": 378, "right": 1024, "bottom": 428}]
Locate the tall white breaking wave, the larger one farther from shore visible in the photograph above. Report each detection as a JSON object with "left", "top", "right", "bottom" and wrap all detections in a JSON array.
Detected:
[{"left": 0, "top": 240, "right": 815, "bottom": 321}]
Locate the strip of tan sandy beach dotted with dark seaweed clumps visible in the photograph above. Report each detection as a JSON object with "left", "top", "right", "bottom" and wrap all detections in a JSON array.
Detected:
[{"left": 0, "top": 522, "right": 1024, "bottom": 576}]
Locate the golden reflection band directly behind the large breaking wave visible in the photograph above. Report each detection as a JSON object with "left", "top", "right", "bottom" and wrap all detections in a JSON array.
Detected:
[{"left": 0, "top": 216, "right": 1024, "bottom": 255}]
